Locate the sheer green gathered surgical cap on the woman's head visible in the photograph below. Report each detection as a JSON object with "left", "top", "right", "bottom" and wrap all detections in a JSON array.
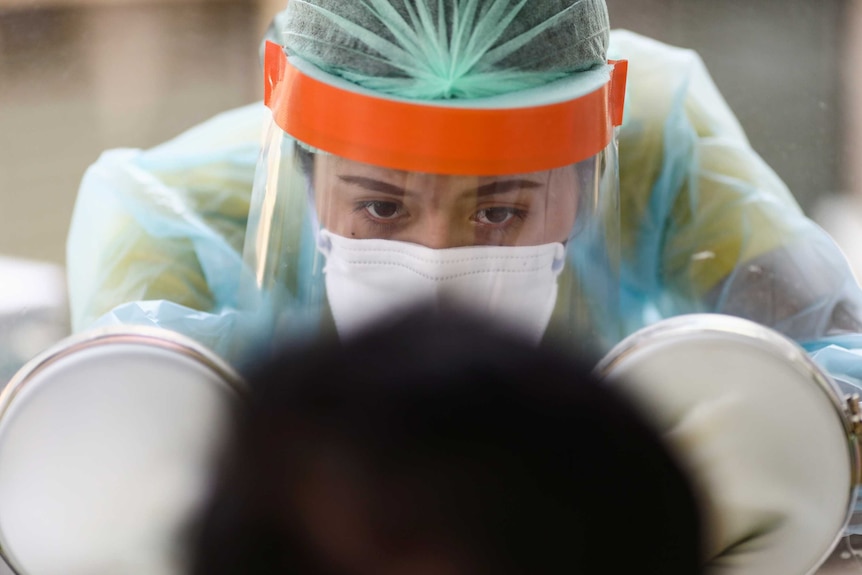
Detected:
[{"left": 274, "top": 0, "right": 610, "bottom": 100}]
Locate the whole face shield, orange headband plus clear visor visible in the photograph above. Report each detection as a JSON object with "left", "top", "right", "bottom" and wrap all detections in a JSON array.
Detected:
[{"left": 241, "top": 39, "right": 626, "bottom": 351}]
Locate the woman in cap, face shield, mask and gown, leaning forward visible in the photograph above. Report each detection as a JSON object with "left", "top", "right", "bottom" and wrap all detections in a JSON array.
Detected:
[{"left": 68, "top": 0, "right": 862, "bottom": 572}]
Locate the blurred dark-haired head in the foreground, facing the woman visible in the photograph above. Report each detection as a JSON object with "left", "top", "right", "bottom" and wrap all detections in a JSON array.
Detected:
[{"left": 193, "top": 314, "right": 700, "bottom": 575}]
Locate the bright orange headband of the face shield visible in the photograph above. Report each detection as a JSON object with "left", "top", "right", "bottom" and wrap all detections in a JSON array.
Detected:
[{"left": 264, "top": 42, "right": 628, "bottom": 175}]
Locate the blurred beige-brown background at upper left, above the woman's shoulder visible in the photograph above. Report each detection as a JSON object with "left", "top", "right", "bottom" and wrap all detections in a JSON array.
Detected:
[{"left": 0, "top": 0, "right": 281, "bottom": 263}]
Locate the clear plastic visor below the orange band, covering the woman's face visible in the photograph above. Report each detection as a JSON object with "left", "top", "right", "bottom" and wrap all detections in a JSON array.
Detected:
[{"left": 242, "top": 126, "right": 620, "bottom": 351}]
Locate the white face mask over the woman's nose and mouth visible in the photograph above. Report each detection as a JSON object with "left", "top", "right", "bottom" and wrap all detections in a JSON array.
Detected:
[{"left": 318, "top": 230, "right": 565, "bottom": 343}]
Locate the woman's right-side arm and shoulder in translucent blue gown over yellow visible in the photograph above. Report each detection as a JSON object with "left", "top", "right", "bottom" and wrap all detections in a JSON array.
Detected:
[{"left": 612, "top": 32, "right": 862, "bottom": 341}]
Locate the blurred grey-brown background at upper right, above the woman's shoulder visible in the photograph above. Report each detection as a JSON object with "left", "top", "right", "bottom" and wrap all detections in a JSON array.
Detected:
[{"left": 608, "top": 0, "right": 852, "bottom": 214}]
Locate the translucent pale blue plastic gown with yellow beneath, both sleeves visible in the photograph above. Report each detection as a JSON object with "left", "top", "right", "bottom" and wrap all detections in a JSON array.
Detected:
[{"left": 67, "top": 27, "right": 862, "bottom": 570}]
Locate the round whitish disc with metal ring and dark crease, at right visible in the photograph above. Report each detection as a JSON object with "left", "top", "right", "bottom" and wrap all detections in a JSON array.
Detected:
[{"left": 597, "top": 314, "right": 859, "bottom": 575}]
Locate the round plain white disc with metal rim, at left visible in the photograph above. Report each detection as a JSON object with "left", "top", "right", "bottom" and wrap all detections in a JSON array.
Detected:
[{"left": 0, "top": 327, "right": 242, "bottom": 575}]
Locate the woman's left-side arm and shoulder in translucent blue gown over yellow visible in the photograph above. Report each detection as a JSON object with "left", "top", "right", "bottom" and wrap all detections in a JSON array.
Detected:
[{"left": 67, "top": 104, "right": 266, "bottom": 358}]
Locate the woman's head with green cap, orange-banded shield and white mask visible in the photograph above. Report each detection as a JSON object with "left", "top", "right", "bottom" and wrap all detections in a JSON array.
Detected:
[{"left": 245, "top": 0, "right": 625, "bottom": 352}]
